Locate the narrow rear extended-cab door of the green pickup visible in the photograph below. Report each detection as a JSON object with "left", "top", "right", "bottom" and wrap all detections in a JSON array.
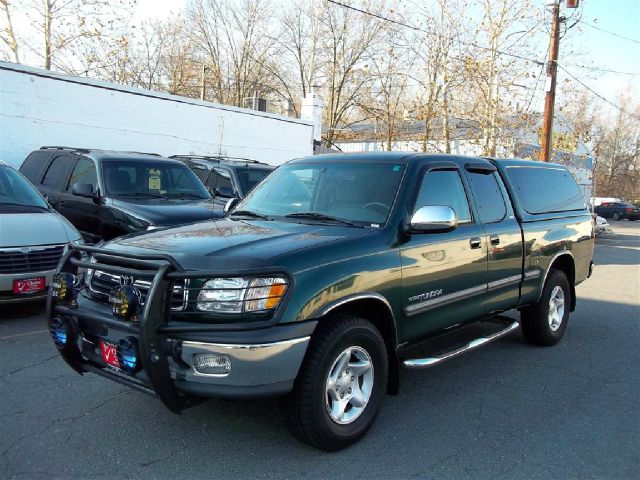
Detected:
[{"left": 465, "top": 160, "right": 523, "bottom": 314}]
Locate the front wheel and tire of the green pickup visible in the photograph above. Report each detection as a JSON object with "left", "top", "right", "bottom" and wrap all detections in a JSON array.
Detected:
[{"left": 282, "top": 315, "right": 388, "bottom": 451}]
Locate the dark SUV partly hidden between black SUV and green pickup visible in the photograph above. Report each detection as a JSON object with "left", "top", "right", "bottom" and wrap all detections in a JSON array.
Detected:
[{"left": 169, "top": 155, "right": 276, "bottom": 208}]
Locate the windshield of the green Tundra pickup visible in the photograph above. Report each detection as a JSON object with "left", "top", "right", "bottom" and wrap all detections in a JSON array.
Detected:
[{"left": 232, "top": 162, "right": 404, "bottom": 227}]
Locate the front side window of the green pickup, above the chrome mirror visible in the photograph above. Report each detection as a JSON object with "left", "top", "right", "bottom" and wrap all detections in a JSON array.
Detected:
[{"left": 413, "top": 170, "right": 471, "bottom": 223}]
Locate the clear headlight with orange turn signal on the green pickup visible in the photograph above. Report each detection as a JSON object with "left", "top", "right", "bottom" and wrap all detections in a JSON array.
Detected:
[{"left": 196, "top": 276, "right": 289, "bottom": 313}]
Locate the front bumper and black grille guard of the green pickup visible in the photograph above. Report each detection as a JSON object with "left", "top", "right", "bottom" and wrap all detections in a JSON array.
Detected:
[{"left": 47, "top": 247, "right": 316, "bottom": 412}]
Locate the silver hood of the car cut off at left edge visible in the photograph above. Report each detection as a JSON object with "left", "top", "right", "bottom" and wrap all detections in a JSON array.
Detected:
[{"left": 0, "top": 212, "right": 81, "bottom": 247}]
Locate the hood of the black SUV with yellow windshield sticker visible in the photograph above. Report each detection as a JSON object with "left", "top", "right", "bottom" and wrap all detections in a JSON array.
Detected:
[{"left": 112, "top": 198, "right": 223, "bottom": 225}]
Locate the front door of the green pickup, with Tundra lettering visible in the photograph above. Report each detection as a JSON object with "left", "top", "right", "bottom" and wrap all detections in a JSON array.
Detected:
[{"left": 400, "top": 162, "right": 487, "bottom": 341}]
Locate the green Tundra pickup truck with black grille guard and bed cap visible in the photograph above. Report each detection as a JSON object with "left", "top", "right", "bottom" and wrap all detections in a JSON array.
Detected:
[{"left": 47, "top": 153, "right": 594, "bottom": 450}]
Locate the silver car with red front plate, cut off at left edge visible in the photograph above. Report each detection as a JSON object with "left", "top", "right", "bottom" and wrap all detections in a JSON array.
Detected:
[{"left": 0, "top": 162, "right": 81, "bottom": 305}]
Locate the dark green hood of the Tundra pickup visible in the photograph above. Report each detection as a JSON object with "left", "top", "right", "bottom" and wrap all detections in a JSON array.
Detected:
[{"left": 104, "top": 218, "right": 369, "bottom": 270}]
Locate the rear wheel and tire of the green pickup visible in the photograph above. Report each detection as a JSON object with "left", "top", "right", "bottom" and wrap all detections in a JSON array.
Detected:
[{"left": 520, "top": 270, "right": 571, "bottom": 346}]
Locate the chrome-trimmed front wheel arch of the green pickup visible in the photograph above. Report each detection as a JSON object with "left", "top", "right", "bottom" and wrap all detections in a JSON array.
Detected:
[{"left": 314, "top": 292, "right": 400, "bottom": 395}]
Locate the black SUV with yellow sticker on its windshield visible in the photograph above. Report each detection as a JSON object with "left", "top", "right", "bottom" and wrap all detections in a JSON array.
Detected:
[{"left": 20, "top": 147, "right": 223, "bottom": 242}]
